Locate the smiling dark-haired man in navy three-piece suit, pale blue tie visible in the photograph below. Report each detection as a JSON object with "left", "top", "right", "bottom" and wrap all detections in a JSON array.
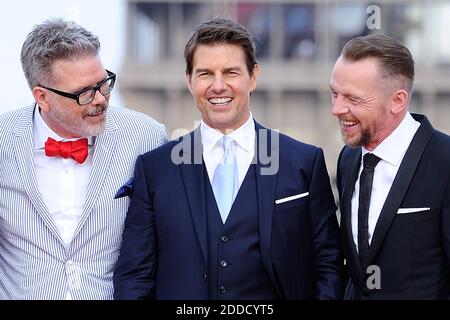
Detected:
[{"left": 114, "top": 18, "right": 343, "bottom": 299}]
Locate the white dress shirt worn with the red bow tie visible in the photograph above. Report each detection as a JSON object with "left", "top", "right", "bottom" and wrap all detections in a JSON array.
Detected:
[{"left": 33, "top": 107, "right": 94, "bottom": 300}]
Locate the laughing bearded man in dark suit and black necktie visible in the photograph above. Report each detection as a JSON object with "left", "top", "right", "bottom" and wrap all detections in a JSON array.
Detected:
[{"left": 330, "top": 35, "right": 450, "bottom": 299}]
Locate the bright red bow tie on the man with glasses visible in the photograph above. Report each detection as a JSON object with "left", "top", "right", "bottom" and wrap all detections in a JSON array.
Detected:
[{"left": 45, "top": 138, "right": 88, "bottom": 163}]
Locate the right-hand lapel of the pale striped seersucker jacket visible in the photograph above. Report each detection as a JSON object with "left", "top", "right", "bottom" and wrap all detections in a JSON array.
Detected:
[{"left": 73, "top": 113, "right": 118, "bottom": 239}]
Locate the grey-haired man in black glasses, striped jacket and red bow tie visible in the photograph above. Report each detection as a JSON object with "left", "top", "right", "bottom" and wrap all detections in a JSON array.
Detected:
[{"left": 0, "top": 19, "right": 167, "bottom": 299}]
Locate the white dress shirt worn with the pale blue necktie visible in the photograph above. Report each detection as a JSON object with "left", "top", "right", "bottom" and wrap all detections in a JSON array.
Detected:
[{"left": 200, "top": 113, "right": 255, "bottom": 192}]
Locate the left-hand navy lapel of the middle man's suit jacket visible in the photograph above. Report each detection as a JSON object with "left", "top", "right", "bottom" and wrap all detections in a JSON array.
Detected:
[{"left": 176, "top": 127, "right": 208, "bottom": 263}]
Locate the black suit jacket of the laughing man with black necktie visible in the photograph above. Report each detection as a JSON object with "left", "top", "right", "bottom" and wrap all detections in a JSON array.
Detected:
[{"left": 337, "top": 114, "right": 450, "bottom": 299}]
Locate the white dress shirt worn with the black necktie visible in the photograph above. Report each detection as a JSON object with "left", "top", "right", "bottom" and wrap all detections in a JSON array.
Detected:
[{"left": 352, "top": 112, "right": 420, "bottom": 247}]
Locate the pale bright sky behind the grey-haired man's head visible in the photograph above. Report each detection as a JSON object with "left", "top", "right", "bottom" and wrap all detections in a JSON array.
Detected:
[{"left": 0, "top": 0, "right": 126, "bottom": 114}]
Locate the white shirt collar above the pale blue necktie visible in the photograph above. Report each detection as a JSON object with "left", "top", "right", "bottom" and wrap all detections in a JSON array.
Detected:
[{"left": 200, "top": 112, "right": 255, "bottom": 153}]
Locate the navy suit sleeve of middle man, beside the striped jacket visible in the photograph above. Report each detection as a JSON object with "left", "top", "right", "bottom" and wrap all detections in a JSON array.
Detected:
[{"left": 114, "top": 156, "right": 157, "bottom": 300}]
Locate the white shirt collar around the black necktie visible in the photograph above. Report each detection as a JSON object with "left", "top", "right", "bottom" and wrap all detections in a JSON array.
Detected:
[{"left": 361, "top": 112, "right": 420, "bottom": 166}]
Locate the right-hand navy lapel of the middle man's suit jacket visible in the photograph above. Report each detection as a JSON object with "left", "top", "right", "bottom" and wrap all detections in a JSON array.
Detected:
[{"left": 253, "top": 121, "right": 282, "bottom": 297}]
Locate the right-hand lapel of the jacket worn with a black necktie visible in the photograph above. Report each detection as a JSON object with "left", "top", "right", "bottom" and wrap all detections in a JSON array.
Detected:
[{"left": 368, "top": 115, "right": 433, "bottom": 264}]
